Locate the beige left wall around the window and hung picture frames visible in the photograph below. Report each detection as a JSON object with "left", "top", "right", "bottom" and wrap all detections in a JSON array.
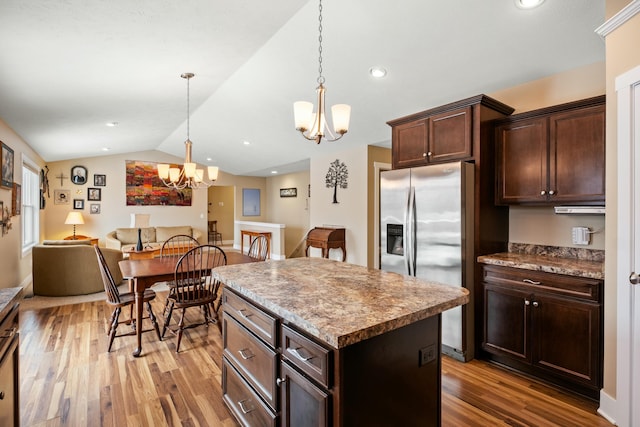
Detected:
[{"left": 0, "top": 119, "right": 44, "bottom": 288}]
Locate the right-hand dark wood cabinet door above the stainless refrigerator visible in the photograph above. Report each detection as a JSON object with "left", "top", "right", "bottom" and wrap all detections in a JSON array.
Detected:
[{"left": 427, "top": 107, "right": 473, "bottom": 163}]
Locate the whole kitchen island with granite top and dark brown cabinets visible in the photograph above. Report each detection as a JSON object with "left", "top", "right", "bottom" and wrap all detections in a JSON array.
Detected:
[{"left": 213, "top": 258, "right": 469, "bottom": 427}]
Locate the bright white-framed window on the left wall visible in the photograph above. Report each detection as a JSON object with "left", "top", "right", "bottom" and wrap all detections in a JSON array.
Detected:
[{"left": 22, "top": 155, "right": 40, "bottom": 255}]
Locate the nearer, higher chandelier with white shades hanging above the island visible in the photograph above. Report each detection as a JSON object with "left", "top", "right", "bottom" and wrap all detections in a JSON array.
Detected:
[{"left": 293, "top": 0, "right": 351, "bottom": 144}]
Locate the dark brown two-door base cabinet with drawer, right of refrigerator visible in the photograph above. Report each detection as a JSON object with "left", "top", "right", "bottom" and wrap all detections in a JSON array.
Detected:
[{"left": 482, "top": 265, "right": 603, "bottom": 399}]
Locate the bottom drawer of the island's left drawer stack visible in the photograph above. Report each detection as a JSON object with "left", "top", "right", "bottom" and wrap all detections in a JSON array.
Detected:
[{"left": 222, "top": 357, "right": 276, "bottom": 427}]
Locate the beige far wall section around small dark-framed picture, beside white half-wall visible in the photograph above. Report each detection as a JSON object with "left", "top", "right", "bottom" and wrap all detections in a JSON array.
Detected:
[{"left": 267, "top": 171, "right": 309, "bottom": 258}]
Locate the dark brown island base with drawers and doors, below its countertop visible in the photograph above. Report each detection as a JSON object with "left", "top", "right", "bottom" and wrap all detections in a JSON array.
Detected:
[{"left": 222, "top": 288, "right": 441, "bottom": 427}]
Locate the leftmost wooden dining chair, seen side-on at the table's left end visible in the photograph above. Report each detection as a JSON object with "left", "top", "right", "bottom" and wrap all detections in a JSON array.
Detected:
[{"left": 93, "top": 245, "right": 162, "bottom": 352}]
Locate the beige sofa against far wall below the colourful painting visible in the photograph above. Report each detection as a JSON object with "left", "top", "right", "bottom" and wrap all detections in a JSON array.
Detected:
[{"left": 105, "top": 225, "right": 202, "bottom": 252}]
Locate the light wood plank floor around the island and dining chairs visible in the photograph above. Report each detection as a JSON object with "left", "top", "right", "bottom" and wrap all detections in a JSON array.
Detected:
[{"left": 20, "top": 292, "right": 611, "bottom": 427}]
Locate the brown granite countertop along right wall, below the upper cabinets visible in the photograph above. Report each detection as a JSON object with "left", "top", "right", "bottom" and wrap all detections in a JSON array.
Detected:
[{"left": 478, "top": 246, "right": 604, "bottom": 280}]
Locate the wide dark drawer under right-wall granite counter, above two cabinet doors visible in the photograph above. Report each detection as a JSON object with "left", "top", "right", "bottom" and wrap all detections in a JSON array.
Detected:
[{"left": 483, "top": 265, "right": 601, "bottom": 301}]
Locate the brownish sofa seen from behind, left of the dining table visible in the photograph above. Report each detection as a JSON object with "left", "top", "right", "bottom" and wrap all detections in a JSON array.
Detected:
[{"left": 32, "top": 240, "right": 122, "bottom": 296}]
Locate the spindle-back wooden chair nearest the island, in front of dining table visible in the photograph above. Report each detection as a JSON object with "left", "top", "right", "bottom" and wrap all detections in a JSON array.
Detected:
[{"left": 162, "top": 245, "right": 227, "bottom": 353}]
